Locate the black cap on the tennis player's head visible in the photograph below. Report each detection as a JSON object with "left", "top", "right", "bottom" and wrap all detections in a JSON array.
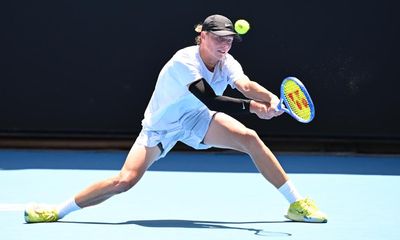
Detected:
[{"left": 201, "top": 14, "right": 239, "bottom": 37}]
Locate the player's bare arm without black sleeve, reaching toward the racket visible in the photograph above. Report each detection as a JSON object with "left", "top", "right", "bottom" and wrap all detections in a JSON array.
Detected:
[{"left": 235, "top": 76, "right": 283, "bottom": 116}]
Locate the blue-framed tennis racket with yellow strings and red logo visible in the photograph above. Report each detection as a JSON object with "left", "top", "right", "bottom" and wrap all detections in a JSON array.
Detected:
[{"left": 277, "top": 77, "right": 315, "bottom": 123}]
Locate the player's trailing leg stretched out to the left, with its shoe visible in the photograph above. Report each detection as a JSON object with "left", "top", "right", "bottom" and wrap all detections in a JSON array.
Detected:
[{"left": 25, "top": 143, "right": 161, "bottom": 223}]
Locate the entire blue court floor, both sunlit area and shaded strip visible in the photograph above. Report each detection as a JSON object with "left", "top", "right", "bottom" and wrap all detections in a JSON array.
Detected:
[{"left": 0, "top": 150, "right": 400, "bottom": 240}]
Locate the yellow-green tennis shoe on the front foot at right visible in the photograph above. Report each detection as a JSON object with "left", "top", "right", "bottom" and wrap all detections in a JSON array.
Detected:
[{"left": 285, "top": 198, "right": 328, "bottom": 223}]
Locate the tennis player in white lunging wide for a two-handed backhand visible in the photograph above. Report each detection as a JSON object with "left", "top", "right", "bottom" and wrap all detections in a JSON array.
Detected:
[{"left": 25, "top": 15, "right": 327, "bottom": 223}]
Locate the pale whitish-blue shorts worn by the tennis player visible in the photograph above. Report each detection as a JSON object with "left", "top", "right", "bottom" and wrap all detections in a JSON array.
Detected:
[{"left": 135, "top": 109, "right": 216, "bottom": 159}]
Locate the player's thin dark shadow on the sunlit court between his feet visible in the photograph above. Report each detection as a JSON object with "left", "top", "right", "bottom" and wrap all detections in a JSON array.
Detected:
[{"left": 57, "top": 219, "right": 295, "bottom": 236}]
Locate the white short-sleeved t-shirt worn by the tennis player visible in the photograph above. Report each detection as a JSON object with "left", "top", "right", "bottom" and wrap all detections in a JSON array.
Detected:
[{"left": 142, "top": 46, "right": 244, "bottom": 131}]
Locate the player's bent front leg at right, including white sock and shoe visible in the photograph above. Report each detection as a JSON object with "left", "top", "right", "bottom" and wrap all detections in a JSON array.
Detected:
[{"left": 204, "top": 113, "right": 327, "bottom": 222}]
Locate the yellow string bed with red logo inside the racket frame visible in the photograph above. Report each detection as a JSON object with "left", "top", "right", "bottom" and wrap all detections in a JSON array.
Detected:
[{"left": 283, "top": 80, "right": 312, "bottom": 120}]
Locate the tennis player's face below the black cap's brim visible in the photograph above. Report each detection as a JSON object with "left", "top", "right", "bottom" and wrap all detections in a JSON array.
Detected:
[{"left": 202, "top": 32, "right": 233, "bottom": 60}]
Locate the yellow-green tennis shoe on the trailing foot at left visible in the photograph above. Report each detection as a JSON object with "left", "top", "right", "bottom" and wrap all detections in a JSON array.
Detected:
[{"left": 24, "top": 204, "right": 58, "bottom": 223}]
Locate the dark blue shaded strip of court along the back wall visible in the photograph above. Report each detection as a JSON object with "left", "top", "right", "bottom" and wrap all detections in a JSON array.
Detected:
[{"left": 0, "top": 150, "right": 400, "bottom": 175}]
